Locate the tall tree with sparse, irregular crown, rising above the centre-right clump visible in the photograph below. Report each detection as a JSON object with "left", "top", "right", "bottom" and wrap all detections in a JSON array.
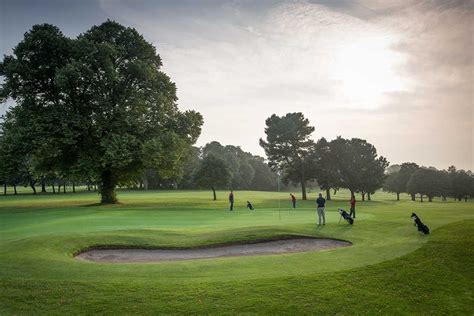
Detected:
[{"left": 260, "top": 112, "right": 314, "bottom": 200}]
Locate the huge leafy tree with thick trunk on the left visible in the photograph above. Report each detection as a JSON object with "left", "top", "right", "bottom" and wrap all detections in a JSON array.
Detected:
[{"left": 0, "top": 21, "right": 202, "bottom": 203}]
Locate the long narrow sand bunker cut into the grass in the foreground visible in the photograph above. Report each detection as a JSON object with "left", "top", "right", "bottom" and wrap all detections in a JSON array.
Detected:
[{"left": 76, "top": 238, "right": 352, "bottom": 263}]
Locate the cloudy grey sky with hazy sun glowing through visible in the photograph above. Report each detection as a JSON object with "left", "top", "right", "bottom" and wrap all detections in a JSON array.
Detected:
[{"left": 0, "top": 0, "right": 474, "bottom": 170}]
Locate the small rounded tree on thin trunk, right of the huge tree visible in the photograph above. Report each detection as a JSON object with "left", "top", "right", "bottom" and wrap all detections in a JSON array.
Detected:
[{"left": 194, "top": 154, "right": 231, "bottom": 201}]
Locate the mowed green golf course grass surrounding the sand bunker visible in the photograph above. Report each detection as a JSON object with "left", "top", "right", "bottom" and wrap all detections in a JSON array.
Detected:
[{"left": 0, "top": 191, "right": 474, "bottom": 315}]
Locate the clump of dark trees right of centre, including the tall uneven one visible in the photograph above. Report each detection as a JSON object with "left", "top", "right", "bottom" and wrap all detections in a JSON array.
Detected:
[{"left": 260, "top": 112, "right": 389, "bottom": 200}]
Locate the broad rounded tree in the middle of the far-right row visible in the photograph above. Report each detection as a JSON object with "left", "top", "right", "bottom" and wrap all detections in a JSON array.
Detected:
[{"left": 407, "top": 168, "right": 445, "bottom": 202}]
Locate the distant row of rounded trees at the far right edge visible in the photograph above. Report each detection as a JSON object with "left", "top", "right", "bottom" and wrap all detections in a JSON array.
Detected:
[{"left": 383, "top": 163, "right": 474, "bottom": 202}]
